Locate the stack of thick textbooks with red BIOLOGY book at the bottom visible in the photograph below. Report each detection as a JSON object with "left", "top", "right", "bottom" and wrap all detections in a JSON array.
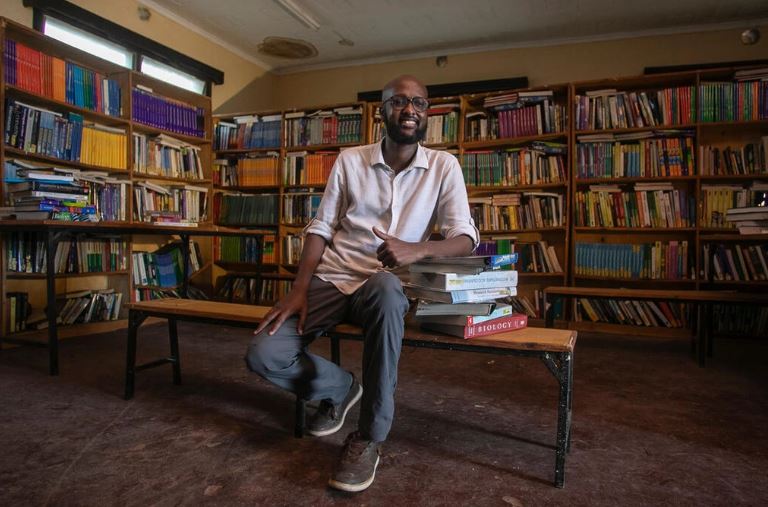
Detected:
[{"left": 404, "top": 253, "right": 528, "bottom": 338}]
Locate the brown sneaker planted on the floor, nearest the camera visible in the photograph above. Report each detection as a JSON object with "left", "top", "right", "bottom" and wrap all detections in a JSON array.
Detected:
[{"left": 328, "top": 431, "right": 381, "bottom": 492}]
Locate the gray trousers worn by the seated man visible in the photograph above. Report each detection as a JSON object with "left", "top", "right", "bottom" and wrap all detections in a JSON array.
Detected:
[{"left": 245, "top": 272, "right": 408, "bottom": 442}]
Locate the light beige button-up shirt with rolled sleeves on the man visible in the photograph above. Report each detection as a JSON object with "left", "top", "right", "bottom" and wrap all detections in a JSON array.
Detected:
[{"left": 304, "top": 143, "right": 479, "bottom": 294}]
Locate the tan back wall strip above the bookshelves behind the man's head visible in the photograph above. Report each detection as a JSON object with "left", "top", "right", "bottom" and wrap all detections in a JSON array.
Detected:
[{"left": 274, "top": 26, "right": 768, "bottom": 108}]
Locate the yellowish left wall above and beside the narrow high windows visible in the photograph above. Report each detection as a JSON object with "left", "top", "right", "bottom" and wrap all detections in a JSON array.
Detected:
[{"left": 0, "top": 0, "right": 274, "bottom": 111}]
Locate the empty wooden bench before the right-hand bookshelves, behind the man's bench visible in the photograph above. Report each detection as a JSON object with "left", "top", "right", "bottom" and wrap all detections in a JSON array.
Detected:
[{"left": 541, "top": 287, "right": 768, "bottom": 366}]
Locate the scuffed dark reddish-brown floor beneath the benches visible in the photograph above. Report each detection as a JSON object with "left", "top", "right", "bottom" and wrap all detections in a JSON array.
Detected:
[{"left": 0, "top": 324, "right": 768, "bottom": 507}]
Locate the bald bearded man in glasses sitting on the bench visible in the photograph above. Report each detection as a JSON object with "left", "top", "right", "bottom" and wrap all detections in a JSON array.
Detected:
[{"left": 246, "top": 76, "right": 479, "bottom": 491}]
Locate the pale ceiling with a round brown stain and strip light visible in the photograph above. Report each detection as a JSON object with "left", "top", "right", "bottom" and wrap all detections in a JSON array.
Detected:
[{"left": 139, "top": 0, "right": 768, "bottom": 73}]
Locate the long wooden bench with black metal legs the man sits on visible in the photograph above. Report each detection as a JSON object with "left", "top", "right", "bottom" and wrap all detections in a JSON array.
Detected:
[{"left": 125, "top": 299, "right": 576, "bottom": 488}]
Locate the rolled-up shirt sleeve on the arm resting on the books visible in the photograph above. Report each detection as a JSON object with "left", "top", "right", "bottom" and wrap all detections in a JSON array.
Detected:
[{"left": 437, "top": 156, "right": 480, "bottom": 250}]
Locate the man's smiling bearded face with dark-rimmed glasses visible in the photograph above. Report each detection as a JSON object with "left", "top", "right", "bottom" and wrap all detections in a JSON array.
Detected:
[{"left": 381, "top": 76, "right": 427, "bottom": 144}]
